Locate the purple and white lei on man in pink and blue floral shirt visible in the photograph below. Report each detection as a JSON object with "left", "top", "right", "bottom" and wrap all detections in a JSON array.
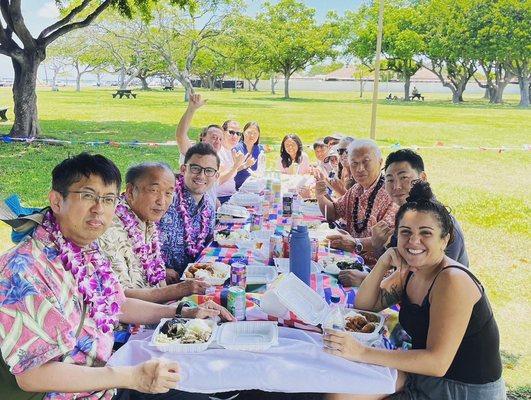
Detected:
[{"left": 42, "top": 211, "right": 120, "bottom": 333}]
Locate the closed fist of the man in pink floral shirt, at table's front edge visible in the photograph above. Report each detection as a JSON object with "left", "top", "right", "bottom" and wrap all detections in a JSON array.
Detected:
[{"left": 128, "top": 359, "right": 180, "bottom": 393}]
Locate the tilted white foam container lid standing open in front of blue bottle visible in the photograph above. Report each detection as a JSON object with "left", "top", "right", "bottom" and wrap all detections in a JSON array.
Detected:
[{"left": 260, "top": 273, "right": 328, "bottom": 325}]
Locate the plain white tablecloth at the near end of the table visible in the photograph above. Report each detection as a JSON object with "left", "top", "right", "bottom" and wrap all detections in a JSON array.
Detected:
[{"left": 109, "top": 327, "right": 397, "bottom": 394}]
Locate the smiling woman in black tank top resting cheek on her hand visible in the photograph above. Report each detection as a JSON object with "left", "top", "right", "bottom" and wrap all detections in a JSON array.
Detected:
[{"left": 323, "top": 182, "right": 505, "bottom": 400}]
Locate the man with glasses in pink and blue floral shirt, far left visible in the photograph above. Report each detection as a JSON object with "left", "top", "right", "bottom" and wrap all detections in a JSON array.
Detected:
[{"left": 0, "top": 153, "right": 231, "bottom": 400}]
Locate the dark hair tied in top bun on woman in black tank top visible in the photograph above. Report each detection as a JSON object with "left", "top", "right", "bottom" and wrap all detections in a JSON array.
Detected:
[{"left": 395, "top": 181, "right": 454, "bottom": 244}]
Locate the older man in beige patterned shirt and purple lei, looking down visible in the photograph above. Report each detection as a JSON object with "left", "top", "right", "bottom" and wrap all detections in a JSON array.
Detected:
[{"left": 99, "top": 163, "right": 208, "bottom": 303}]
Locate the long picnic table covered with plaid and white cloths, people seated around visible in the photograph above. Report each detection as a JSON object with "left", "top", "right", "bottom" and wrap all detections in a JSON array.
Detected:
[{"left": 109, "top": 183, "right": 397, "bottom": 394}]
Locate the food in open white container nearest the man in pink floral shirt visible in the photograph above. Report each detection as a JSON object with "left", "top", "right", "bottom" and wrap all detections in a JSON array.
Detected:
[{"left": 155, "top": 318, "right": 212, "bottom": 344}]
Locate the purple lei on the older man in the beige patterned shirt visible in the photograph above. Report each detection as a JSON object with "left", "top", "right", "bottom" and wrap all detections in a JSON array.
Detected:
[{"left": 116, "top": 194, "right": 166, "bottom": 286}]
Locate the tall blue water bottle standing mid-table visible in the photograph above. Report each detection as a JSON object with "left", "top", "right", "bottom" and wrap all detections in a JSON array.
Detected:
[{"left": 289, "top": 225, "right": 312, "bottom": 286}]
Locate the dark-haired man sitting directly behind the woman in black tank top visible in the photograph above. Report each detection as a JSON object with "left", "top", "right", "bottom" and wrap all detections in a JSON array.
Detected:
[{"left": 378, "top": 149, "right": 468, "bottom": 267}]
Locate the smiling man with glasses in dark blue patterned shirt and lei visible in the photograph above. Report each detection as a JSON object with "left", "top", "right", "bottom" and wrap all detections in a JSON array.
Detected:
[{"left": 159, "top": 143, "right": 220, "bottom": 275}]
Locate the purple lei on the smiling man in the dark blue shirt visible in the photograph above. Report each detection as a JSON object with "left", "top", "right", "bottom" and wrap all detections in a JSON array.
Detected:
[{"left": 175, "top": 175, "right": 211, "bottom": 257}]
